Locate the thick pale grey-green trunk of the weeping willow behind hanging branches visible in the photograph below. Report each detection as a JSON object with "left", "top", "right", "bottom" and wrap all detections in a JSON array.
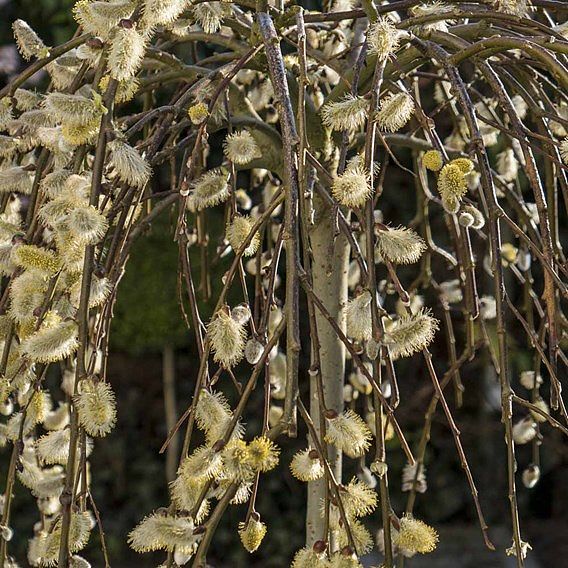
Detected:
[{"left": 306, "top": 199, "right": 349, "bottom": 546}]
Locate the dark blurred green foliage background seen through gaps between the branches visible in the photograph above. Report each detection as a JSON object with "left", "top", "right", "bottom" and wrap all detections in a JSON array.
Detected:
[{"left": 0, "top": 0, "right": 568, "bottom": 568}]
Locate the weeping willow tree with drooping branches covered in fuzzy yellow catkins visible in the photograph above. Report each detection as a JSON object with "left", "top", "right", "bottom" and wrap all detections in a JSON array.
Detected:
[{"left": 0, "top": 0, "right": 568, "bottom": 568}]
